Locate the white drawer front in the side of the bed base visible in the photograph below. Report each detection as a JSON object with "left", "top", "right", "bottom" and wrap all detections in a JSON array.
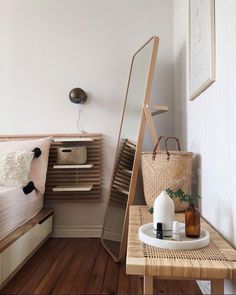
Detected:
[{"left": 2, "top": 216, "right": 52, "bottom": 282}]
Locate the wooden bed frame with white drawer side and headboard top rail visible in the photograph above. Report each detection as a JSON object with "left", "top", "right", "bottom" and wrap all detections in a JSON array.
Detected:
[{"left": 0, "top": 135, "right": 53, "bottom": 289}]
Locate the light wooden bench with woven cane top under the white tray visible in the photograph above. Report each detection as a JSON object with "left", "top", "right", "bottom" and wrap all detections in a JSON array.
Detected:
[{"left": 126, "top": 206, "right": 236, "bottom": 294}]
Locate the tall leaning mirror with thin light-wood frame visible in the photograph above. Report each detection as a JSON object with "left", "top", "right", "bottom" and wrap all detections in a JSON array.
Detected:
[{"left": 102, "top": 36, "right": 159, "bottom": 261}]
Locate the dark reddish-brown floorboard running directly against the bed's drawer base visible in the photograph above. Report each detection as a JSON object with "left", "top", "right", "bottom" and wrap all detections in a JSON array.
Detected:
[{"left": 0, "top": 239, "right": 59, "bottom": 295}]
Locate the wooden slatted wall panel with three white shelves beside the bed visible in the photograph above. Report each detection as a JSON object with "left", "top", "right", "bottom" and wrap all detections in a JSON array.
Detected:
[{"left": 45, "top": 133, "right": 102, "bottom": 202}]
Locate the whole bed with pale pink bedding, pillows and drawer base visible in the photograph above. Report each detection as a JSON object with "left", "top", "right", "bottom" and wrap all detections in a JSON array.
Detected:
[{"left": 0, "top": 136, "right": 53, "bottom": 289}]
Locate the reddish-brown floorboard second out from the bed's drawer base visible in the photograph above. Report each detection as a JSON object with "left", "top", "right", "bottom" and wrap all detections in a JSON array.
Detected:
[{"left": 17, "top": 239, "right": 70, "bottom": 295}]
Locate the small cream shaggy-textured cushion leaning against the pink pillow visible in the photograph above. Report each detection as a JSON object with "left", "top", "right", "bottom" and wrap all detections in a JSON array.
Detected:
[{"left": 0, "top": 151, "right": 34, "bottom": 187}]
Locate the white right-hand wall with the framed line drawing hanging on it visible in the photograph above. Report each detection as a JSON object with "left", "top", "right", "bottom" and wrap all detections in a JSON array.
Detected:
[{"left": 174, "top": 0, "right": 236, "bottom": 293}]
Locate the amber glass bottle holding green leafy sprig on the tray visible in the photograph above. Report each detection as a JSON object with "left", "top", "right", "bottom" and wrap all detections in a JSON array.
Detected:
[{"left": 149, "top": 188, "right": 201, "bottom": 238}]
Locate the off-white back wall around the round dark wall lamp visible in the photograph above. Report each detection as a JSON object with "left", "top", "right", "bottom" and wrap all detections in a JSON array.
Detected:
[{"left": 0, "top": 0, "right": 173, "bottom": 236}]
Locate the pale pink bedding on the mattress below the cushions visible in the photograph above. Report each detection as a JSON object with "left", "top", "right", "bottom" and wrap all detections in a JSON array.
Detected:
[{"left": 0, "top": 186, "right": 43, "bottom": 240}]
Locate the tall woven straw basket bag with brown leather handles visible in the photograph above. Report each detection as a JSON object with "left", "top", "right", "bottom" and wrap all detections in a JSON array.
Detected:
[{"left": 142, "top": 136, "right": 193, "bottom": 212}]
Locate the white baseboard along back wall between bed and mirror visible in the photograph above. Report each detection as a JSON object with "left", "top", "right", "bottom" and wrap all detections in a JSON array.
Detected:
[{"left": 52, "top": 226, "right": 102, "bottom": 238}]
